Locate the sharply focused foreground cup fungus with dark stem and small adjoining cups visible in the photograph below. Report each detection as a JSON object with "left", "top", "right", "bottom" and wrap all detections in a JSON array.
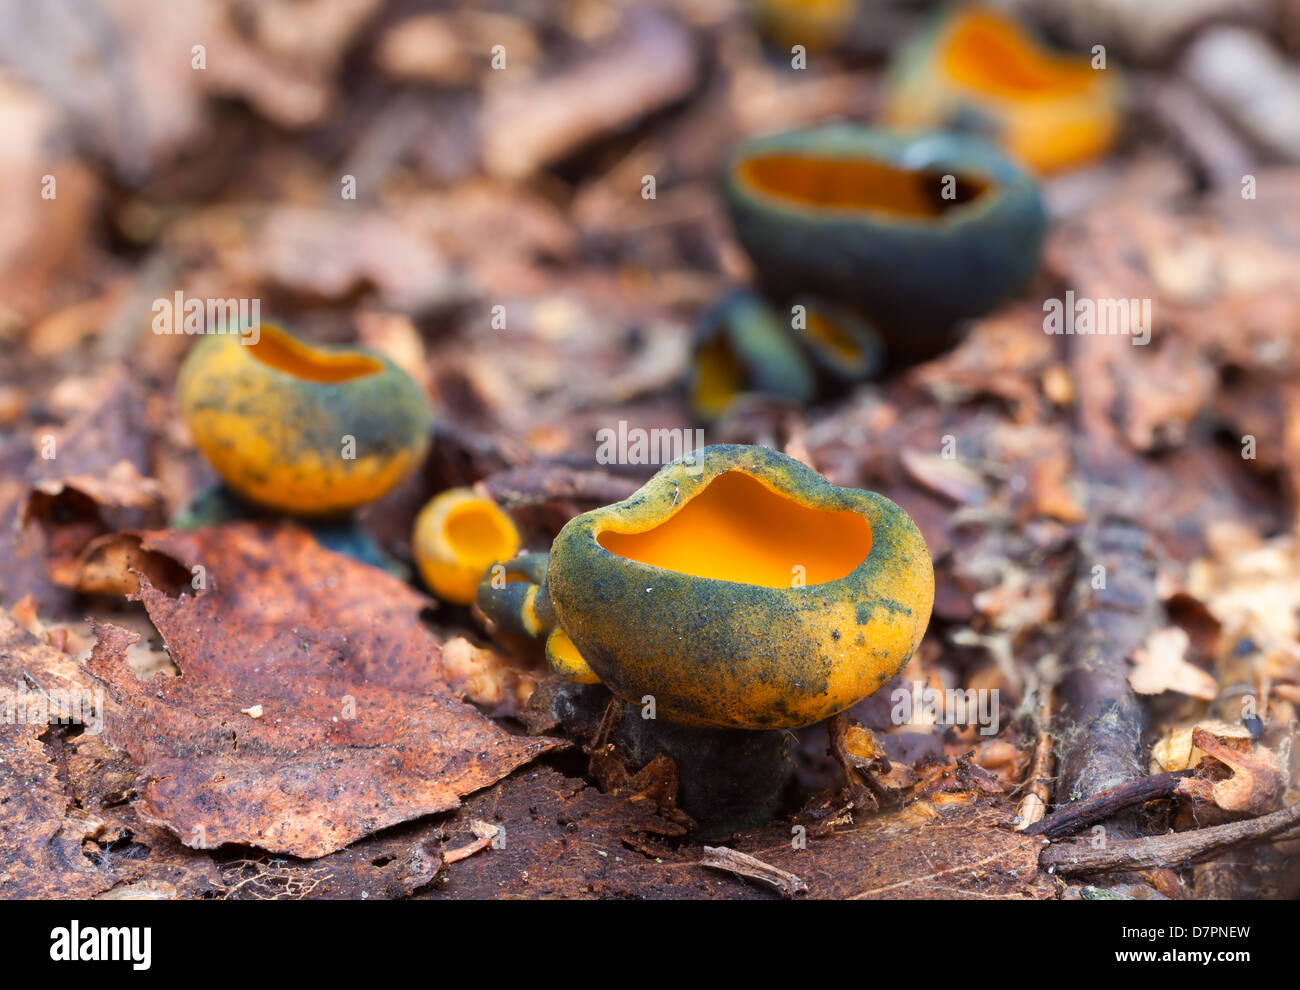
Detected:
[{"left": 478, "top": 444, "right": 935, "bottom": 834}]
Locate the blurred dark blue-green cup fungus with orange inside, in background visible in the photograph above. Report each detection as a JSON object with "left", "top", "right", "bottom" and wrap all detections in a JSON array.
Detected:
[{"left": 723, "top": 123, "right": 1047, "bottom": 335}]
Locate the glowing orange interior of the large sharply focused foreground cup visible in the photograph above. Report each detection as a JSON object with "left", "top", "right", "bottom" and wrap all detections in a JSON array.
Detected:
[{"left": 597, "top": 470, "right": 871, "bottom": 587}]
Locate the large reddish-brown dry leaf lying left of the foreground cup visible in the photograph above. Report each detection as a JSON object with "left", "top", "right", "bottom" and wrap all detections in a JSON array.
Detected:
[{"left": 90, "top": 524, "right": 560, "bottom": 857}]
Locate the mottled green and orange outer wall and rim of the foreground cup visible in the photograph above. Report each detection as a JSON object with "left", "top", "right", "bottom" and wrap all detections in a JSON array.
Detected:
[{"left": 545, "top": 446, "right": 935, "bottom": 729}]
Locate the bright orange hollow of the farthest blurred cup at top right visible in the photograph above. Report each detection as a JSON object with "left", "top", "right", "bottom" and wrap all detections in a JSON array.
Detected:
[{"left": 943, "top": 10, "right": 1096, "bottom": 99}]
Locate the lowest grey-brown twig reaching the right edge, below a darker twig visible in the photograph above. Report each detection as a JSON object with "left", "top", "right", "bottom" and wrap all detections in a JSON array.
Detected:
[{"left": 1039, "top": 804, "right": 1300, "bottom": 877}]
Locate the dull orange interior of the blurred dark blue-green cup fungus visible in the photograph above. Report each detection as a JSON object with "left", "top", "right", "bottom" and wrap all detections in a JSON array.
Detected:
[{"left": 738, "top": 152, "right": 991, "bottom": 220}]
